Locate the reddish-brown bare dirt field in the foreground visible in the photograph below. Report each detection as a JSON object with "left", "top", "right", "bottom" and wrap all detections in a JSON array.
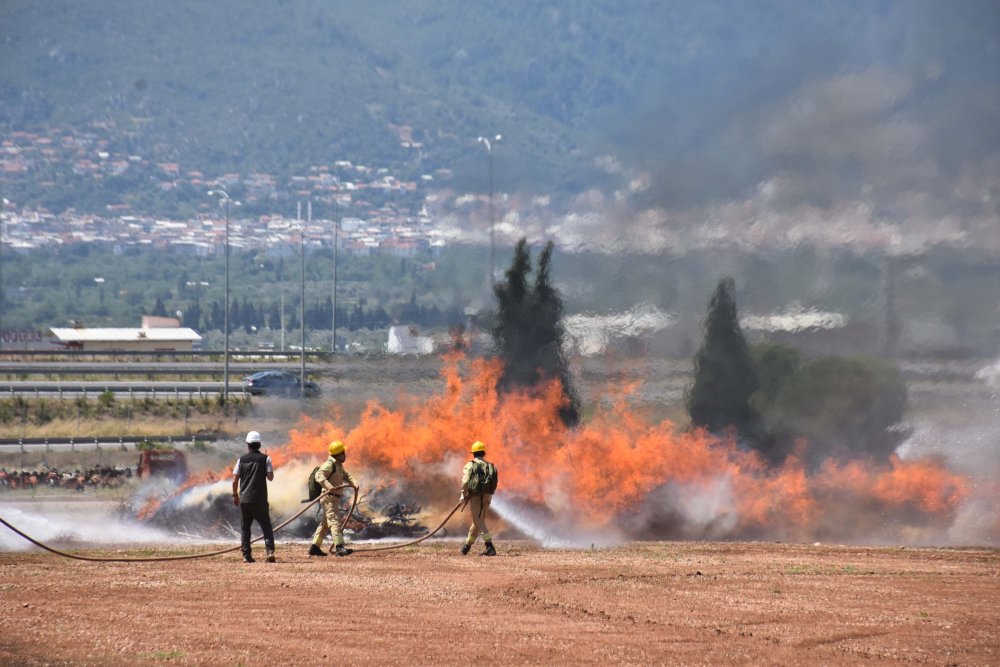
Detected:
[{"left": 0, "top": 540, "right": 1000, "bottom": 665}]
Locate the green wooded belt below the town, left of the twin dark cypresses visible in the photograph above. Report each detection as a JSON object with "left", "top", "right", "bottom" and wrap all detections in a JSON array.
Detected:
[{"left": 2, "top": 245, "right": 483, "bottom": 340}]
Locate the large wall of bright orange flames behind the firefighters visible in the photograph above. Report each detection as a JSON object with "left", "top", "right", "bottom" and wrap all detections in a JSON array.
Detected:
[{"left": 139, "top": 353, "right": 969, "bottom": 538}]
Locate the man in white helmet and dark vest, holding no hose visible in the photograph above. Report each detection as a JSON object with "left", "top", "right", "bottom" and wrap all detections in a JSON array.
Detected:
[{"left": 233, "top": 431, "right": 274, "bottom": 563}]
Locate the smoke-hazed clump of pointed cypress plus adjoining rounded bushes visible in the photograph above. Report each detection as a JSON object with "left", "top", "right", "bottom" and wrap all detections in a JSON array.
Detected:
[{"left": 686, "top": 278, "right": 908, "bottom": 466}]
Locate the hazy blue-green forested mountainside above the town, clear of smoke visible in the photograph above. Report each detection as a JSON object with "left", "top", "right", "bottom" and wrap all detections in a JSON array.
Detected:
[{"left": 0, "top": 0, "right": 987, "bottom": 190}]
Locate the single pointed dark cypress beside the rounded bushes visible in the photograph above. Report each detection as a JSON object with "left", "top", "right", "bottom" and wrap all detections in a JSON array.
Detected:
[{"left": 686, "top": 278, "right": 760, "bottom": 446}]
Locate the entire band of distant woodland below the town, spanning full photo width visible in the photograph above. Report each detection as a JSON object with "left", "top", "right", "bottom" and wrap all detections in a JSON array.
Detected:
[{"left": 0, "top": 244, "right": 1000, "bottom": 354}]
